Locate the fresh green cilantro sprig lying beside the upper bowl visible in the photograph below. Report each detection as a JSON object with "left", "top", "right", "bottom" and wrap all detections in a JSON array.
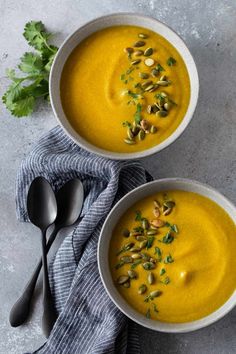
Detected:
[{"left": 2, "top": 21, "right": 58, "bottom": 117}]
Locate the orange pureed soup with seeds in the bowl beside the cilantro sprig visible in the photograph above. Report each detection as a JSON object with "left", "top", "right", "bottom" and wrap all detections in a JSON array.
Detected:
[{"left": 61, "top": 26, "right": 190, "bottom": 153}]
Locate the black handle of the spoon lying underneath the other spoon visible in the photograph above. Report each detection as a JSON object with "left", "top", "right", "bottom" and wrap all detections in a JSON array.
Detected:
[{"left": 9, "top": 227, "right": 59, "bottom": 327}]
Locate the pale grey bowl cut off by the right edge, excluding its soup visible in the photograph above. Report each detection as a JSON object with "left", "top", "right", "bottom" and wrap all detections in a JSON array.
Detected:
[{"left": 98, "top": 178, "right": 236, "bottom": 333}]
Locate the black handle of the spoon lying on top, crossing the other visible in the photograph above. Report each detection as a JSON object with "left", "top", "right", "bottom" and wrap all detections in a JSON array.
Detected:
[{"left": 42, "top": 230, "right": 57, "bottom": 338}]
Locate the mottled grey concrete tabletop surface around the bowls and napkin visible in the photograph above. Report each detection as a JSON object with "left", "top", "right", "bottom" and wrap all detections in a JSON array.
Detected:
[{"left": 0, "top": 0, "right": 236, "bottom": 354}]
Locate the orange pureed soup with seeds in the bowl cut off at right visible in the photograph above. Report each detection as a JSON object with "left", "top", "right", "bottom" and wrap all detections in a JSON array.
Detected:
[{"left": 109, "top": 191, "right": 236, "bottom": 322}]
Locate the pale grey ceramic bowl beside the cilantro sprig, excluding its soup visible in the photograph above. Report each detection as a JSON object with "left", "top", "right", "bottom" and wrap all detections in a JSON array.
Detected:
[{"left": 49, "top": 13, "right": 199, "bottom": 160}]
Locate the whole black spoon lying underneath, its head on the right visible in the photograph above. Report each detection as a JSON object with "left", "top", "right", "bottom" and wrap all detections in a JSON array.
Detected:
[{"left": 9, "top": 178, "right": 84, "bottom": 327}]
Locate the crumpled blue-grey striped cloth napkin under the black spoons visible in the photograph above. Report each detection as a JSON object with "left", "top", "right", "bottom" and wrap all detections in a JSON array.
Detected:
[{"left": 16, "top": 127, "right": 151, "bottom": 354}]
